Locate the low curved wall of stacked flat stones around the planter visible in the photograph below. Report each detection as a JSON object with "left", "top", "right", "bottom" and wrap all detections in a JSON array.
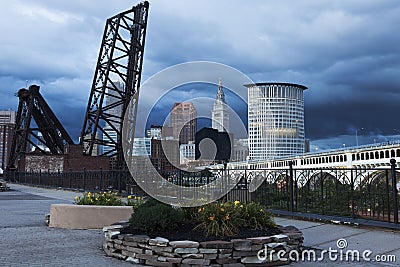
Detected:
[{"left": 103, "top": 225, "right": 303, "bottom": 267}]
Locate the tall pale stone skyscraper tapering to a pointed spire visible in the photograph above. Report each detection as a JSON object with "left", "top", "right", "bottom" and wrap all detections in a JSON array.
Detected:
[{"left": 212, "top": 79, "right": 229, "bottom": 132}]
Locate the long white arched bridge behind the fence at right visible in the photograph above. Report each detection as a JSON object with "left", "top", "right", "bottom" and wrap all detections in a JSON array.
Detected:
[{"left": 214, "top": 142, "right": 400, "bottom": 195}]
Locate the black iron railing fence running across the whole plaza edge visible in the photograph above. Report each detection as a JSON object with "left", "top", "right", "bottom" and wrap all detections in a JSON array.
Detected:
[{"left": 5, "top": 160, "right": 400, "bottom": 224}]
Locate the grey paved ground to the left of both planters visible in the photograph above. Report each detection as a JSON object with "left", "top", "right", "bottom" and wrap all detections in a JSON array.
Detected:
[{"left": 0, "top": 185, "right": 139, "bottom": 267}]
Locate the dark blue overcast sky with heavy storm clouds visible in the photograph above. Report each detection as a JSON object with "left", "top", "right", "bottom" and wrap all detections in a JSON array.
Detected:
[{"left": 0, "top": 0, "right": 400, "bottom": 149}]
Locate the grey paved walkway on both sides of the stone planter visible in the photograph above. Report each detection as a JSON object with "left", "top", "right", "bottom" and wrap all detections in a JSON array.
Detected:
[{"left": 0, "top": 184, "right": 400, "bottom": 267}]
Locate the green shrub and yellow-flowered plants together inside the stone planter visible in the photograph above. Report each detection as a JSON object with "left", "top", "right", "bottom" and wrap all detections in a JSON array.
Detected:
[{"left": 130, "top": 199, "right": 275, "bottom": 237}]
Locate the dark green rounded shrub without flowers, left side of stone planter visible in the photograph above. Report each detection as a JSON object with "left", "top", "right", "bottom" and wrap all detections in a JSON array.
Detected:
[{"left": 129, "top": 200, "right": 184, "bottom": 231}]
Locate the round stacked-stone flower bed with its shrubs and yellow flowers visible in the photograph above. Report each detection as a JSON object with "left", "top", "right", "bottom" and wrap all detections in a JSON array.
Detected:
[{"left": 103, "top": 200, "right": 303, "bottom": 267}]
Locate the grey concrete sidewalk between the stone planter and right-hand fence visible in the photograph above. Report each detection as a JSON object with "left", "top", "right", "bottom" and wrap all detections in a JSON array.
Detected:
[{"left": 275, "top": 217, "right": 400, "bottom": 266}]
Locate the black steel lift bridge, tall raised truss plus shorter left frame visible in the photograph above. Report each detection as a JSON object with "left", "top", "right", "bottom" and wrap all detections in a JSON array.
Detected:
[{"left": 8, "top": 1, "right": 149, "bottom": 170}]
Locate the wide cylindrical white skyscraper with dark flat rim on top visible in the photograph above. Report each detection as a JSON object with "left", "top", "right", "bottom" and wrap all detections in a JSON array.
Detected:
[{"left": 245, "top": 83, "right": 307, "bottom": 160}]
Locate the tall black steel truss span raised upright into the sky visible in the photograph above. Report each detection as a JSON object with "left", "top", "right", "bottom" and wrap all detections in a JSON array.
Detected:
[{"left": 80, "top": 1, "right": 149, "bottom": 168}]
